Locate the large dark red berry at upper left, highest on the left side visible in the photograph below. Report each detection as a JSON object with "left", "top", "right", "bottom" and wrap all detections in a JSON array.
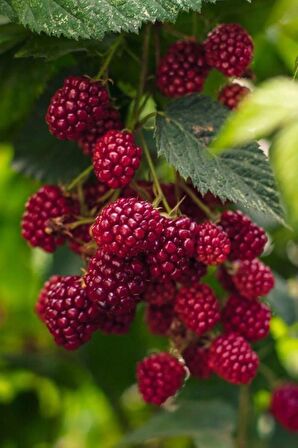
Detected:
[{"left": 46, "top": 76, "right": 109, "bottom": 140}]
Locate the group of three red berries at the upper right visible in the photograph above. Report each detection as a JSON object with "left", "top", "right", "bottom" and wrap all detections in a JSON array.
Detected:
[{"left": 157, "top": 24, "right": 254, "bottom": 109}]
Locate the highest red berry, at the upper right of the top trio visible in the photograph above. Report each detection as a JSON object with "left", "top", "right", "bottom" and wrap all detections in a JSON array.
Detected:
[{"left": 204, "top": 23, "right": 253, "bottom": 76}]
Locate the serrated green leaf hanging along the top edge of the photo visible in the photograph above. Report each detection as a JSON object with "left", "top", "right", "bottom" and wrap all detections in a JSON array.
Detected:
[{"left": 0, "top": 0, "right": 210, "bottom": 39}]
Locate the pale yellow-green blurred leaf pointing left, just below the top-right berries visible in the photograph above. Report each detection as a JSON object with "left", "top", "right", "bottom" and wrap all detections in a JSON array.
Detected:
[{"left": 212, "top": 78, "right": 298, "bottom": 153}]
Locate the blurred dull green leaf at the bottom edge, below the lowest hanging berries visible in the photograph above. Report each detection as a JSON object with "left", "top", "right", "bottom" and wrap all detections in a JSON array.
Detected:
[{"left": 122, "top": 400, "right": 235, "bottom": 448}]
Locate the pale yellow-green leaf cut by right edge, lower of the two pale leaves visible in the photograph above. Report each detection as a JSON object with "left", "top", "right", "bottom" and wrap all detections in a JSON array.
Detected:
[{"left": 272, "top": 123, "right": 298, "bottom": 226}]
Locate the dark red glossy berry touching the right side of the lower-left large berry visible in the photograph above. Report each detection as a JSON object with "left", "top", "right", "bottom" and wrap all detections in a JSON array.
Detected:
[{"left": 84, "top": 249, "right": 147, "bottom": 317}]
